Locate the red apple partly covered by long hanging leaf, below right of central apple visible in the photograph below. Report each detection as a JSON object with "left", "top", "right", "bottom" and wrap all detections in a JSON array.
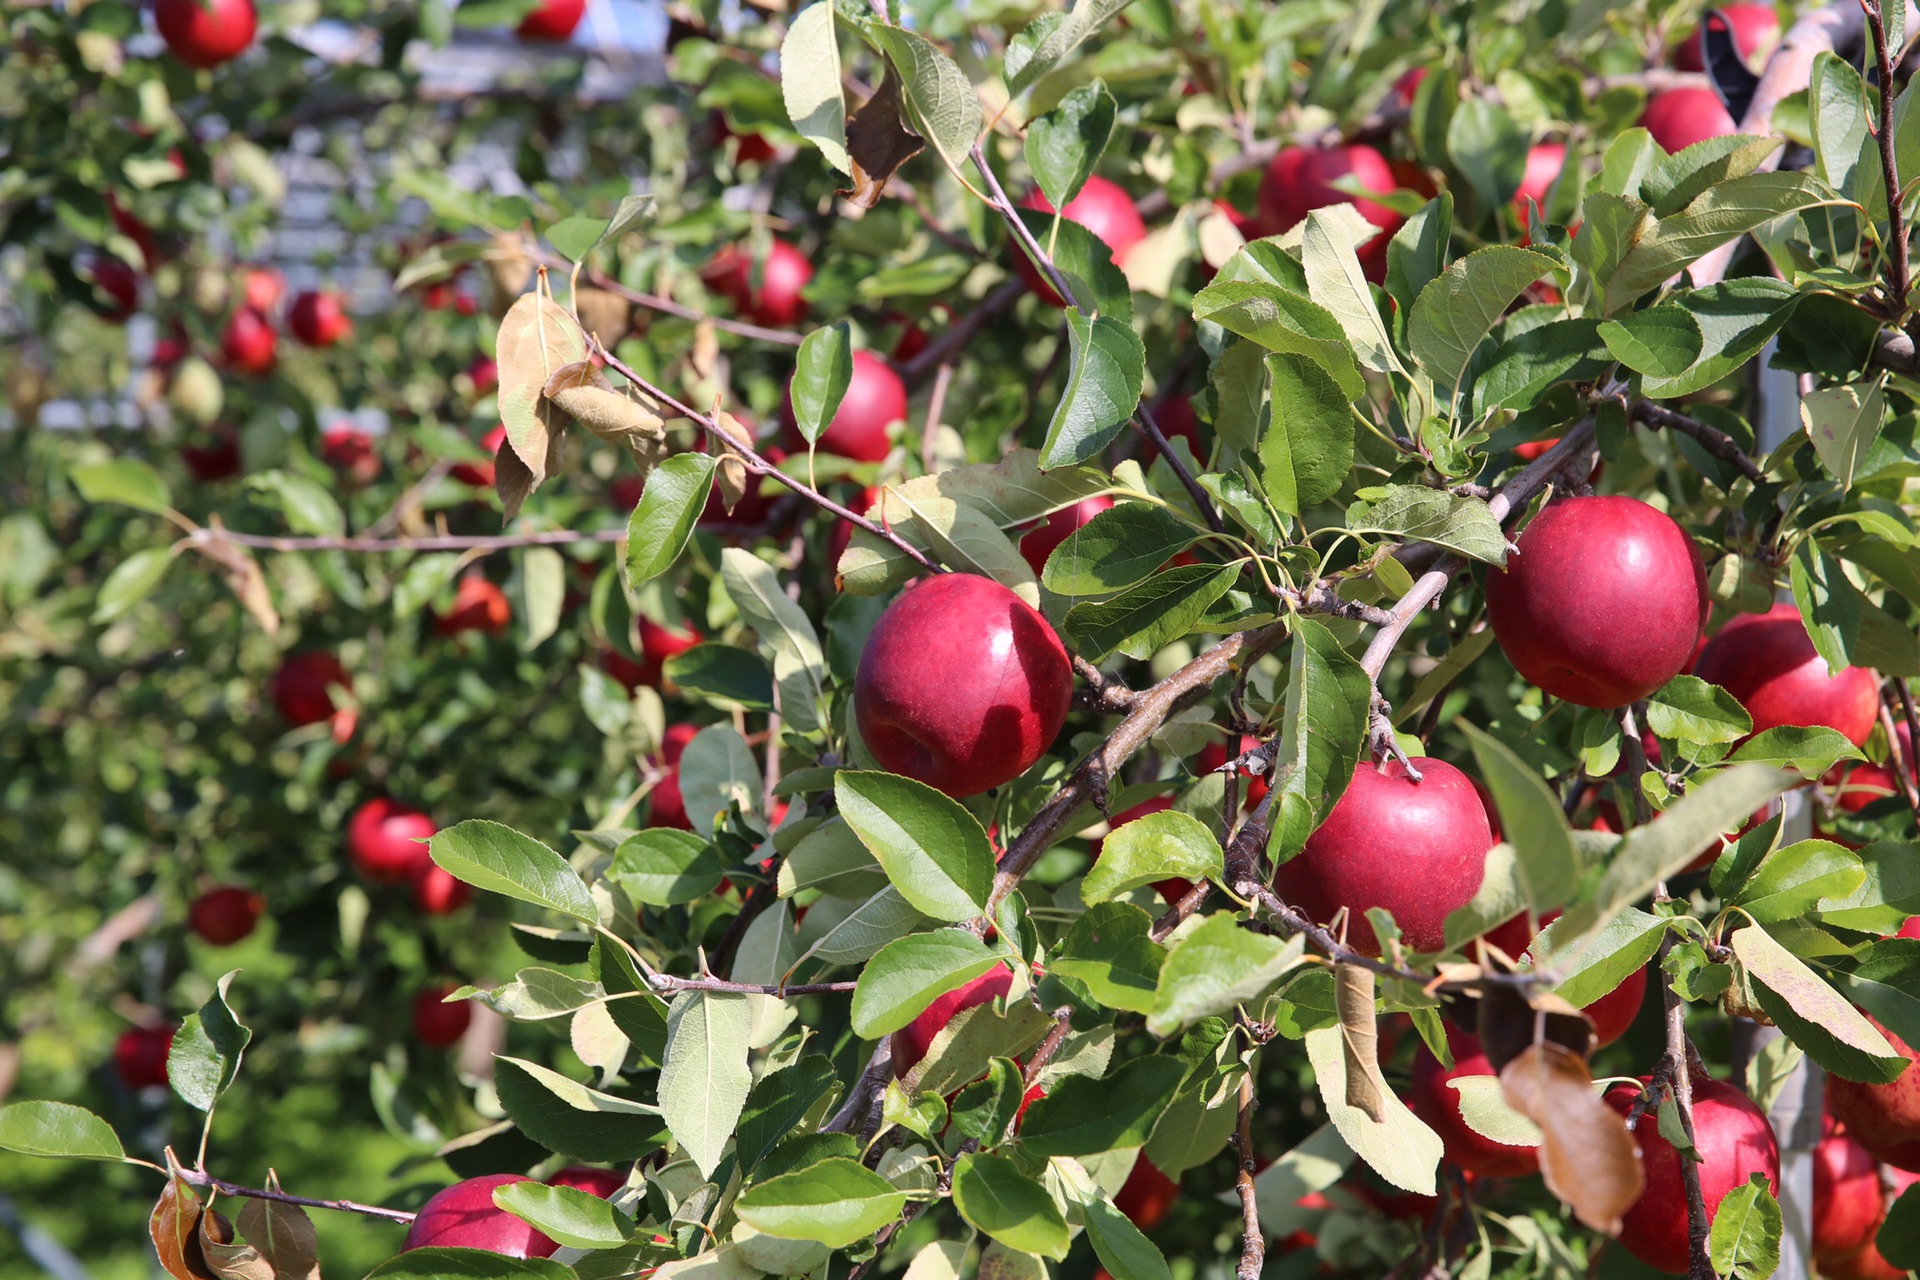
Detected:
[{"left": 1273, "top": 758, "right": 1494, "bottom": 956}]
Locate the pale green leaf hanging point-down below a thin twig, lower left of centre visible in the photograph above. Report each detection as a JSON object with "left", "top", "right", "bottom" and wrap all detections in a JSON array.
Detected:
[{"left": 660, "top": 990, "right": 753, "bottom": 1178}]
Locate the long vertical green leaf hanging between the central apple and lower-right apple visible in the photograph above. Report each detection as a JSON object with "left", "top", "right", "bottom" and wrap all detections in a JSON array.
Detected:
[{"left": 1267, "top": 618, "right": 1373, "bottom": 864}]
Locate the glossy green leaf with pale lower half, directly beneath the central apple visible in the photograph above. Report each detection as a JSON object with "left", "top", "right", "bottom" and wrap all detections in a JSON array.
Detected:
[{"left": 833, "top": 770, "right": 993, "bottom": 921}]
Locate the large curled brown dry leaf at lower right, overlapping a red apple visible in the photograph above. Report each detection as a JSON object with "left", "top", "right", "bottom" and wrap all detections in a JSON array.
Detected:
[{"left": 1500, "top": 1042, "right": 1645, "bottom": 1236}]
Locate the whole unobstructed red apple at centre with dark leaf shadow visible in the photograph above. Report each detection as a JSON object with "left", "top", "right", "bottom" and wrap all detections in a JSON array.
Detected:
[{"left": 854, "top": 574, "right": 1082, "bottom": 794}]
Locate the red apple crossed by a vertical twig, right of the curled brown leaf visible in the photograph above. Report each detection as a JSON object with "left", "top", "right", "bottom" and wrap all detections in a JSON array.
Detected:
[{"left": 1607, "top": 1077, "right": 1780, "bottom": 1276}]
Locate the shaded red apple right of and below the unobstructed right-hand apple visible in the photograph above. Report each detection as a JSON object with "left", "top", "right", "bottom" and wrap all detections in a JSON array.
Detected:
[{"left": 1693, "top": 604, "right": 1880, "bottom": 747}]
